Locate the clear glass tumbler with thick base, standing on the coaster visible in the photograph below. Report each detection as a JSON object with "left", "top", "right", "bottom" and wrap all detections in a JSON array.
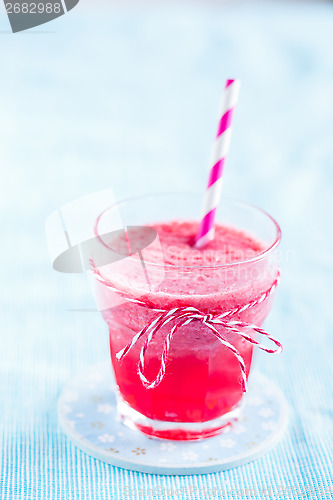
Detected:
[{"left": 92, "top": 193, "right": 281, "bottom": 440}]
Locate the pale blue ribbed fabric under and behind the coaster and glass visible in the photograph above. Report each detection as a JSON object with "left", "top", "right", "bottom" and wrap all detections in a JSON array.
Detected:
[{"left": 0, "top": 0, "right": 333, "bottom": 500}]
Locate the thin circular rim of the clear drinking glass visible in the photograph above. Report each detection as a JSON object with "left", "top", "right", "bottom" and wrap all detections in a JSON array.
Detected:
[{"left": 95, "top": 191, "right": 282, "bottom": 270}]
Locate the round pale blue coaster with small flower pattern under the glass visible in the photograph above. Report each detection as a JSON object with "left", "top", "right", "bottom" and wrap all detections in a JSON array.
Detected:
[{"left": 58, "top": 364, "right": 288, "bottom": 475}]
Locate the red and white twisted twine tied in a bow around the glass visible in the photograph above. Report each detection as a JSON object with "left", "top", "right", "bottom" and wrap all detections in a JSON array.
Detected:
[{"left": 93, "top": 268, "right": 283, "bottom": 393}]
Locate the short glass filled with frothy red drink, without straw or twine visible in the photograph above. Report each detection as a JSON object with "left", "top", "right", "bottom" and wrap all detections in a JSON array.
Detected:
[{"left": 89, "top": 195, "right": 280, "bottom": 439}]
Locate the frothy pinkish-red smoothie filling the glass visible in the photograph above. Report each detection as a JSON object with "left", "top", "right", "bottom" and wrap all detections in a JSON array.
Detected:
[{"left": 95, "top": 221, "right": 275, "bottom": 439}]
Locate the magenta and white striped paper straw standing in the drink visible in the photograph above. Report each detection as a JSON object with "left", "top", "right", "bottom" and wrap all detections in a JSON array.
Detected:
[{"left": 195, "top": 80, "right": 240, "bottom": 248}]
